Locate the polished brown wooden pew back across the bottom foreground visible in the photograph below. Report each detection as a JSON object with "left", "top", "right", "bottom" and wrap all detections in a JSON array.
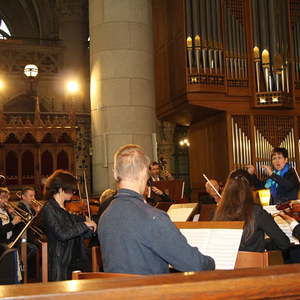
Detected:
[{"left": 0, "top": 264, "right": 300, "bottom": 300}]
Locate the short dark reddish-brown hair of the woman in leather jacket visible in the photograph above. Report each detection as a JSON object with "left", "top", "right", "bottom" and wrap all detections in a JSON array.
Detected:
[{"left": 44, "top": 170, "right": 77, "bottom": 200}]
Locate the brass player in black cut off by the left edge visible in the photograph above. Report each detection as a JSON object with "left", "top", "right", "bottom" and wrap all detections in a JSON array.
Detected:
[{"left": 0, "top": 187, "right": 21, "bottom": 244}]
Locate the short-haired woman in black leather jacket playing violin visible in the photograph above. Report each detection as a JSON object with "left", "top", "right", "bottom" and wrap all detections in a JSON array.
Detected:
[{"left": 42, "top": 170, "right": 96, "bottom": 281}]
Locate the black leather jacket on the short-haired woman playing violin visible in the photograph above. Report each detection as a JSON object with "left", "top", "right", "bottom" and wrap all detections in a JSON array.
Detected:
[{"left": 41, "top": 199, "right": 91, "bottom": 281}]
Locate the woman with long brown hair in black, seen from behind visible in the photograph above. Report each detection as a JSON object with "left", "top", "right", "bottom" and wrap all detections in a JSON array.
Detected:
[{"left": 214, "top": 169, "right": 290, "bottom": 252}]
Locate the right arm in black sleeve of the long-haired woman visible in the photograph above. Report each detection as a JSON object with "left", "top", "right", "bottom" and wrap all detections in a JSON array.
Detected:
[{"left": 257, "top": 209, "right": 290, "bottom": 250}]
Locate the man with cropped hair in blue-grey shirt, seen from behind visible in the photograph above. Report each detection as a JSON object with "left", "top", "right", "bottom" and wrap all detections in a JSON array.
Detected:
[{"left": 98, "top": 145, "right": 215, "bottom": 274}]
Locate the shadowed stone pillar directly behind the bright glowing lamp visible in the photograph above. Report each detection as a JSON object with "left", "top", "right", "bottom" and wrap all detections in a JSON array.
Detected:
[{"left": 57, "top": 0, "right": 89, "bottom": 111}]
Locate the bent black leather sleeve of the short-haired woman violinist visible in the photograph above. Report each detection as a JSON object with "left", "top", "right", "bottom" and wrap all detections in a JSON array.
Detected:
[{"left": 42, "top": 207, "right": 90, "bottom": 241}]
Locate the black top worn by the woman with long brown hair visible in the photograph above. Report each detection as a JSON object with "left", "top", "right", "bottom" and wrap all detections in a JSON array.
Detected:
[{"left": 239, "top": 205, "right": 290, "bottom": 252}]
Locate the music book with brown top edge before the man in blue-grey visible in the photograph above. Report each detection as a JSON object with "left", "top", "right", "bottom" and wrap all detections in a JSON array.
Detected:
[{"left": 176, "top": 221, "right": 244, "bottom": 270}]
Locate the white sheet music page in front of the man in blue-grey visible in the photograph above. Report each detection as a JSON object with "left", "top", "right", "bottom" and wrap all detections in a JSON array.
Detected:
[{"left": 180, "top": 228, "right": 243, "bottom": 270}]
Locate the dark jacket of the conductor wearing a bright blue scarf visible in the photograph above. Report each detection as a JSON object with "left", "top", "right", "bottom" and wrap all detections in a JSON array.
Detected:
[{"left": 252, "top": 168, "right": 299, "bottom": 205}]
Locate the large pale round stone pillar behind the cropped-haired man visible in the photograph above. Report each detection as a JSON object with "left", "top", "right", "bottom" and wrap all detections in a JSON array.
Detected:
[{"left": 89, "top": 0, "right": 155, "bottom": 192}]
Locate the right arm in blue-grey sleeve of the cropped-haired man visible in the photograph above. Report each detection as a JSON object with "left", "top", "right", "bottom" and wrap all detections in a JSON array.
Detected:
[{"left": 150, "top": 214, "right": 215, "bottom": 272}]
